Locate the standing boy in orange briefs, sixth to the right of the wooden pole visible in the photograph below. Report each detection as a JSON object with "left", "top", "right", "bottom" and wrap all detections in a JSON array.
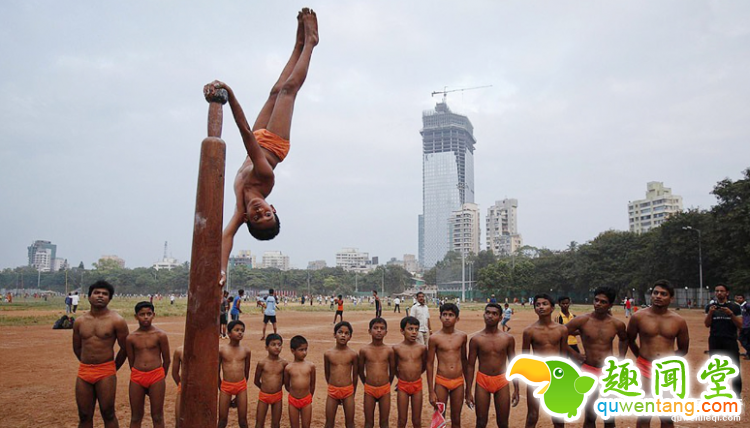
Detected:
[{"left": 393, "top": 316, "right": 427, "bottom": 428}]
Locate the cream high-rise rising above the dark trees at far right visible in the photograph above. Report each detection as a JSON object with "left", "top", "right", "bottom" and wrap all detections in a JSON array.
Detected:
[{"left": 628, "top": 181, "right": 682, "bottom": 234}]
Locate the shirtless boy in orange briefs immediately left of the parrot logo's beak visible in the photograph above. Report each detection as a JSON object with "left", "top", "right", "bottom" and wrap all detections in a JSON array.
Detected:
[{"left": 466, "top": 303, "right": 518, "bottom": 428}]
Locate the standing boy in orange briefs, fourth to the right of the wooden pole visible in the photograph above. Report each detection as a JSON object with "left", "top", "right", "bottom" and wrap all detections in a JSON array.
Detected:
[{"left": 323, "top": 321, "right": 359, "bottom": 428}]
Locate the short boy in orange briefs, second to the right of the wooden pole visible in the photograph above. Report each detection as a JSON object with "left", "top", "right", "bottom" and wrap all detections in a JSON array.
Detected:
[{"left": 253, "top": 333, "right": 288, "bottom": 428}]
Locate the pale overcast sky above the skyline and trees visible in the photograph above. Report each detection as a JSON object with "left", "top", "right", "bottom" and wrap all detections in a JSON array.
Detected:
[{"left": 0, "top": 0, "right": 750, "bottom": 268}]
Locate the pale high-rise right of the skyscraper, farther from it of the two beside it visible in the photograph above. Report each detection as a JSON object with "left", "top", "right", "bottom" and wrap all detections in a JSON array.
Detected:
[{"left": 485, "top": 199, "right": 523, "bottom": 256}]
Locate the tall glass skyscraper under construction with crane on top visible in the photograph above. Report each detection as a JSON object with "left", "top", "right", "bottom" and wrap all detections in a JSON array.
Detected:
[{"left": 419, "top": 101, "right": 476, "bottom": 268}]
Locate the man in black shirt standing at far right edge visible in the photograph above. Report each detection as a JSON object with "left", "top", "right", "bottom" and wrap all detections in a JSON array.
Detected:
[{"left": 705, "top": 284, "right": 742, "bottom": 398}]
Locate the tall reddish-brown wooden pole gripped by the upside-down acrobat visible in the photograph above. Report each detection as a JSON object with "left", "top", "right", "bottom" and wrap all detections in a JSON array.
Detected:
[{"left": 177, "top": 89, "right": 227, "bottom": 428}]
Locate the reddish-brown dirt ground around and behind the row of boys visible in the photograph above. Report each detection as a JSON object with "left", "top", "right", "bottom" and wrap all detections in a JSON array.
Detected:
[{"left": 0, "top": 306, "right": 750, "bottom": 428}]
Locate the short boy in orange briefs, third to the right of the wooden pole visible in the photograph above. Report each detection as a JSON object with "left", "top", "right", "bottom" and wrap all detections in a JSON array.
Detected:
[{"left": 284, "top": 336, "right": 315, "bottom": 428}]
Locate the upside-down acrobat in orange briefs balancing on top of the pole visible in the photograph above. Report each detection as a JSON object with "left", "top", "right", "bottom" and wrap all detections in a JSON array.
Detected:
[{"left": 219, "top": 8, "right": 318, "bottom": 284}]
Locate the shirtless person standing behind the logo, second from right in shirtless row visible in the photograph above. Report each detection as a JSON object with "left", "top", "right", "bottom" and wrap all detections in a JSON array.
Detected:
[{"left": 565, "top": 287, "right": 628, "bottom": 428}]
